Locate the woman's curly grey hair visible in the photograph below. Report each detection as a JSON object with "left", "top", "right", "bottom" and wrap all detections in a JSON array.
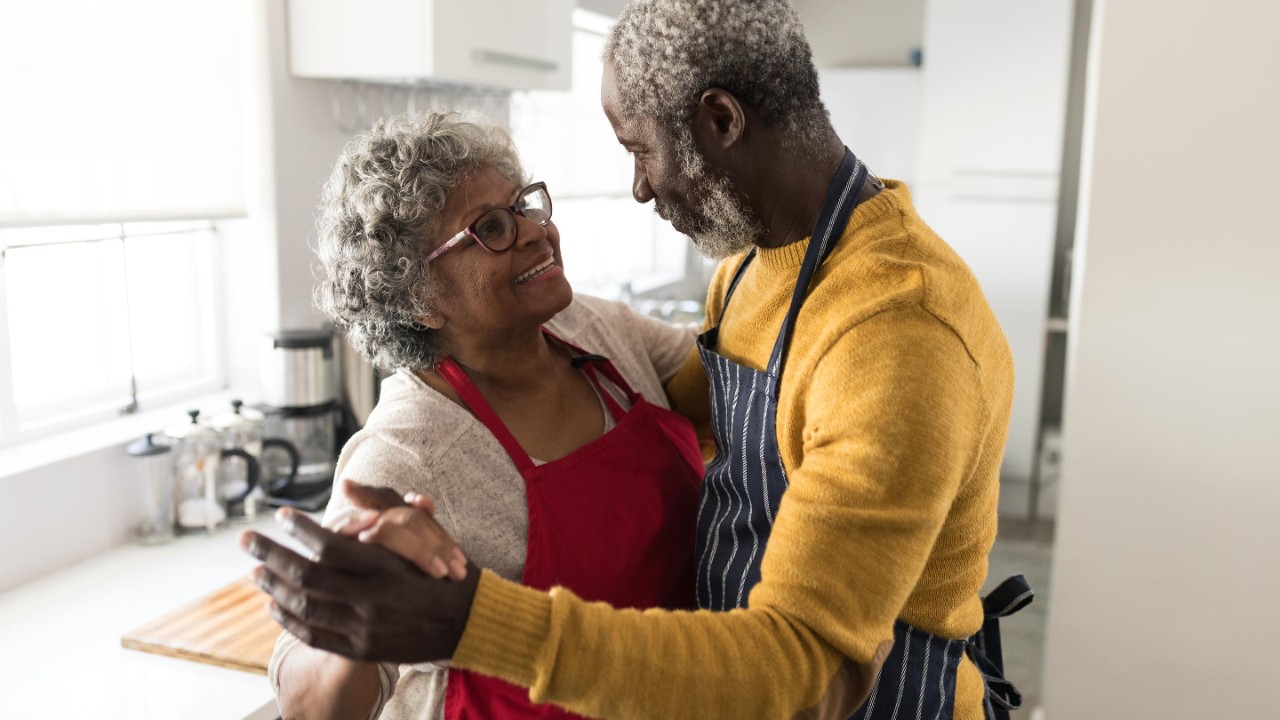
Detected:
[{"left": 315, "top": 113, "right": 527, "bottom": 370}]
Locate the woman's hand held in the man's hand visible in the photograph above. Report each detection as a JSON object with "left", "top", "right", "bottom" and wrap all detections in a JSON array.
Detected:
[{"left": 334, "top": 480, "right": 467, "bottom": 580}]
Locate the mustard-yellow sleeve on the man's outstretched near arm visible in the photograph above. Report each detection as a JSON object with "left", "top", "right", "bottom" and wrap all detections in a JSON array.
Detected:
[{"left": 454, "top": 307, "right": 984, "bottom": 719}]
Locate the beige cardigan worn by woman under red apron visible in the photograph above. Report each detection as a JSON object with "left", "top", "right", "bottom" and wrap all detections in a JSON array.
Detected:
[{"left": 268, "top": 296, "right": 694, "bottom": 720}]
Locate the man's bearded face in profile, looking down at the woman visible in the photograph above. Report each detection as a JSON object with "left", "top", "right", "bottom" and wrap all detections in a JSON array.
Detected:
[{"left": 600, "top": 61, "right": 764, "bottom": 260}]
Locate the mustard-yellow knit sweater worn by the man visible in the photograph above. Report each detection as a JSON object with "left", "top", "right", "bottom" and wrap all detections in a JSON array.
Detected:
[{"left": 453, "top": 182, "right": 1014, "bottom": 720}]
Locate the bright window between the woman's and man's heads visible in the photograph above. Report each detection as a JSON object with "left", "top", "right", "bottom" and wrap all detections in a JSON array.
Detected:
[{"left": 511, "top": 9, "right": 710, "bottom": 302}]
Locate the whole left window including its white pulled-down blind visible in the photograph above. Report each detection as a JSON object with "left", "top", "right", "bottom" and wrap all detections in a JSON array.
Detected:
[{"left": 0, "top": 0, "right": 244, "bottom": 446}]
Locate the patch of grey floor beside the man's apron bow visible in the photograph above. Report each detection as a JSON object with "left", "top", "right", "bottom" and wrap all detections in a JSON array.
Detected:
[{"left": 983, "top": 518, "right": 1053, "bottom": 720}]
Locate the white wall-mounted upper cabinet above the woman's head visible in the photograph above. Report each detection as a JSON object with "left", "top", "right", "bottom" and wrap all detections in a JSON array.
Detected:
[{"left": 288, "top": 0, "right": 573, "bottom": 90}]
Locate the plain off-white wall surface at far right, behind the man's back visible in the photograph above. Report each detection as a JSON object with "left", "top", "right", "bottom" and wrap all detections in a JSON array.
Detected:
[{"left": 1046, "top": 0, "right": 1280, "bottom": 720}]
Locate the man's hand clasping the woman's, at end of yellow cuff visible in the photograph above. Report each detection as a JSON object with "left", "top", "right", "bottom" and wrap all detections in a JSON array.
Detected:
[{"left": 241, "top": 509, "right": 480, "bottom": 662}]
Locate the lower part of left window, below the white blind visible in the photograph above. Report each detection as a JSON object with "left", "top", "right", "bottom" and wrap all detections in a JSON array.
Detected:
[{"left": 0, "top": 222, "right": 223, "bottom": 443}]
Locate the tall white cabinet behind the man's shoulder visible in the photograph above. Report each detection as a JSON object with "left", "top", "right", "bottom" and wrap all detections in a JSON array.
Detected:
[{"left": 914, "top": 0, "right": 1074, "bottom": 491}]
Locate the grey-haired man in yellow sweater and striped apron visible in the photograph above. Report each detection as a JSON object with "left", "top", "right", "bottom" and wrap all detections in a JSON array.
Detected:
[{"left": 250, "top": 0, "right": 1029, "bottom": 719}]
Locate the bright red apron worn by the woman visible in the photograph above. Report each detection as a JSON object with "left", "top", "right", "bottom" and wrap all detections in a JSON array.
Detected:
[{"left": 435, "top": 333, "right": 703, "bottom": 720}]
